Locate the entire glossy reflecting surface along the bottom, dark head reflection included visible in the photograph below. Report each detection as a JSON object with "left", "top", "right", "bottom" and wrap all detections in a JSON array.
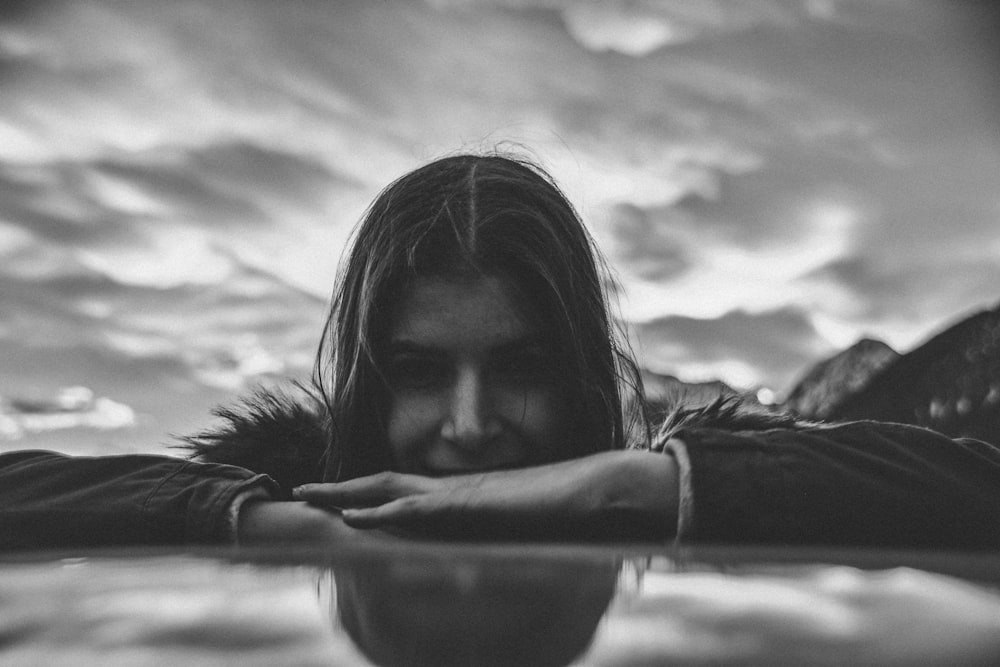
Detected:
[{"left": 0, "top": 544, "right": 1000, "bottom": 667}]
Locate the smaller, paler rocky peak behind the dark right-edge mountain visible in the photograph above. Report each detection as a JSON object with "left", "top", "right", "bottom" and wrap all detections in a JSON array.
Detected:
[{"left": 785, "top": 338, "right": 900, "bottom": 419}]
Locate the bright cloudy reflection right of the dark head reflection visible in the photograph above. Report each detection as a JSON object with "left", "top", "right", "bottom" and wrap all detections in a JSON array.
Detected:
[{"left": 583, "top": 558, "right": 1000, "bottom": 666}]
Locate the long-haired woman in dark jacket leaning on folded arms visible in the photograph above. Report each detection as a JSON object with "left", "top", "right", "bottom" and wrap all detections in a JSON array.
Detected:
[{"left": 0, "top": 155, "right": 1000, "bottom": 547}]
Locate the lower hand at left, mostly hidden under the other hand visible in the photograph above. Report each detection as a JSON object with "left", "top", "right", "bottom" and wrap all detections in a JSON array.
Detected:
[{"left": 236, "top": 500, "right": 400, "bottom": 546}]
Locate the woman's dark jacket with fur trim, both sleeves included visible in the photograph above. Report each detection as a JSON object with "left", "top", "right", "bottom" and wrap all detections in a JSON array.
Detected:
[{"left": 0, "top": 392, "right": 1000, "bottom": 549}]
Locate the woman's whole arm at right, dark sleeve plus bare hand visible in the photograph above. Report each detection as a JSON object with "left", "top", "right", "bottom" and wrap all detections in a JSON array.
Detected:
[{"left": 295, "top": 422, "right": 1000, "bottom": 548}]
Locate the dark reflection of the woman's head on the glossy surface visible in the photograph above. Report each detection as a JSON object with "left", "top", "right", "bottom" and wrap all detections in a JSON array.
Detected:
[{"left": 331, "top": 556, "right": 618, "bottom": 666}]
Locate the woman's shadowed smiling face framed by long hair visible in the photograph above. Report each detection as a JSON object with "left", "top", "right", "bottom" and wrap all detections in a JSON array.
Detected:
[{"left": 384, "top": 275, "right": 566, "bottom": 475}]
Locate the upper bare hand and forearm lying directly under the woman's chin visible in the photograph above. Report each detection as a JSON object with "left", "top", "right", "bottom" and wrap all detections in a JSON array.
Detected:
[{"left": 294, "top": 451, "right": 678, "bottom": 540}]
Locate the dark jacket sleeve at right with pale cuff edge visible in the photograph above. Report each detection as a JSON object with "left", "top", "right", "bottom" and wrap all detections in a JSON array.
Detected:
[{"left": 667, "top": 422, "right": 1000, "bottom": 549}]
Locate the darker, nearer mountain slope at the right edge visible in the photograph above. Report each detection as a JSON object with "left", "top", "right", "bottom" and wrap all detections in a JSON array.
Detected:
[{"left": 829, "top": 304, "right": 1000, "bottom": 444}]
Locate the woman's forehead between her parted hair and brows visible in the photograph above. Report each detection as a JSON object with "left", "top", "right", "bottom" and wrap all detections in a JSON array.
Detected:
[{"left": 389, "top": 275, "right": 535, "bottom": 347}]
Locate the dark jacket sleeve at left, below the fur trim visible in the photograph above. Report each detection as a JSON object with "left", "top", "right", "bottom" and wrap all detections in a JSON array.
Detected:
[{"left": 0, "top": 450, "right": 277, "bottom": 549}]
